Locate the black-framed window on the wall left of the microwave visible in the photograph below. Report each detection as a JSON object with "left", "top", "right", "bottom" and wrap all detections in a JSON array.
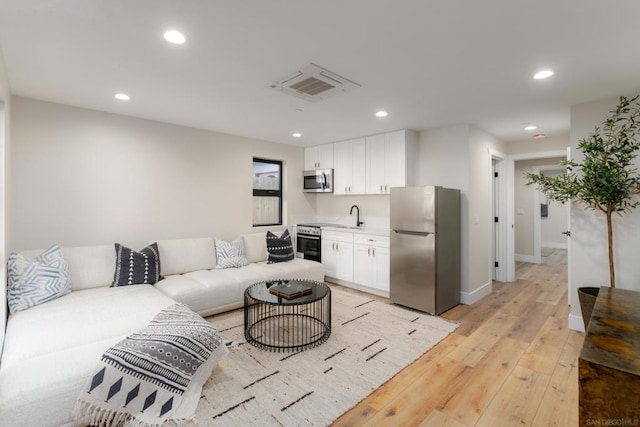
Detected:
[{"left": 253, "top": 157, "right": 282, "bottom": 227}]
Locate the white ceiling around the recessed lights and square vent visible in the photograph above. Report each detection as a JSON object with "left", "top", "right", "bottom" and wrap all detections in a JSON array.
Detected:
[{"left": 0, "top": 0, "right": 640, "bottom": 146}]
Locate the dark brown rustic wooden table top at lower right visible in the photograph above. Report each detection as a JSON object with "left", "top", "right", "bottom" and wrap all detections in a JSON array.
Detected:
[{"left": 580, "top": 287, "right": 640, "bottom": 375}]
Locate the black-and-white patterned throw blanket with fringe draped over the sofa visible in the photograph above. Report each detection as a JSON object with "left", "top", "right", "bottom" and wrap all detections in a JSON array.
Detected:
[{"left": 73, "top": 304, "right": 228, "bottom": 427}]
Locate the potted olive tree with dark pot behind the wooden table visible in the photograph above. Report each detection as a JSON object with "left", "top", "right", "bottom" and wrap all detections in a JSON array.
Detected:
[{"left": 526, "top": 96, "right": 640, "bottom": 330}]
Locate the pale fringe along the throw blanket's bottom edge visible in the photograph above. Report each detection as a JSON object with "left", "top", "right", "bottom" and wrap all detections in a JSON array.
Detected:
[{"left": 73, "top": 399, "right": 198, "bottom": 427}]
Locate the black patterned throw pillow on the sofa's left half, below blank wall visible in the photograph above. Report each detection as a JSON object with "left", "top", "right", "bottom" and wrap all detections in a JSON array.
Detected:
[{"left": 111, "top": 243, "right": 162, "bottom": 287}]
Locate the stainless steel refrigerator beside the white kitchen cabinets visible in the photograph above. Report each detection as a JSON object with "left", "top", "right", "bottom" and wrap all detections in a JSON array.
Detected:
[{"left": 390, "top": 186, "right": 460, "bottom": 315}]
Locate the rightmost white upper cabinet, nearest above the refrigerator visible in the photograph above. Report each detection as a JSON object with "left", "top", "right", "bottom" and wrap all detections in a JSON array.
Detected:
[{"left": 366, "top": 130, "right": 418, "bottom": 194}]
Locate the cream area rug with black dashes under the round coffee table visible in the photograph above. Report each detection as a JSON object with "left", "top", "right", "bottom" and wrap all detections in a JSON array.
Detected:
[{"left": 196, "top": 287, "right": 458, "bottom": 426}]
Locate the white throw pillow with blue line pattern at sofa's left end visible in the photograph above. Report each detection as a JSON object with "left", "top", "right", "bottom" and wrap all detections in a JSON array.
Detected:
[{"left": 7, "top": 245, "right": 71, "bottom": 313}]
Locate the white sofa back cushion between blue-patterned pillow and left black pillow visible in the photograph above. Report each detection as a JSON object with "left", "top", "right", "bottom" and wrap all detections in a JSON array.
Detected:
[{"left": 20, "top": 245, "right": 116, "bottom": 291}]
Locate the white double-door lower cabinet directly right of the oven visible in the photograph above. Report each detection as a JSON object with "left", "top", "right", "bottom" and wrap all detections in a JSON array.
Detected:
[{"left": 321, "top": 230, "right": 353, "bottom": 282}]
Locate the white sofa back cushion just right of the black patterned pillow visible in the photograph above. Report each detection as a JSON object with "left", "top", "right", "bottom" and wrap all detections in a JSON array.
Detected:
[{"left": 157, "top": 237, "right": 216, "bottom": 276}]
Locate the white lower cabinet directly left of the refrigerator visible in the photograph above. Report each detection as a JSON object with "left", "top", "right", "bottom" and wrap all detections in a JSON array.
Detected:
[{"left": 353, "top": 234, "right": 390, "bottom": 292}]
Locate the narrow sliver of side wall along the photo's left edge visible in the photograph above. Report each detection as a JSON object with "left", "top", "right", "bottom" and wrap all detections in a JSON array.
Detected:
[{"left": 0, "top": 46, "right": 11, "bottom": 355}]
